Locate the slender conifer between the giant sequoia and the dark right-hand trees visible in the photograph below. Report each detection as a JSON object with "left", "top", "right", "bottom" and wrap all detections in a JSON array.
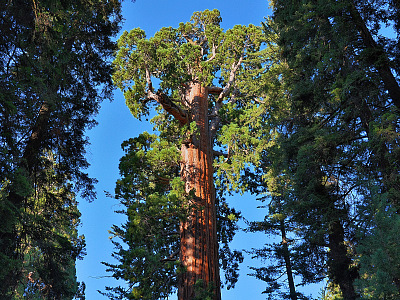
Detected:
[{"left": 243, "top": 99, "right": 326, "bottom": 300}]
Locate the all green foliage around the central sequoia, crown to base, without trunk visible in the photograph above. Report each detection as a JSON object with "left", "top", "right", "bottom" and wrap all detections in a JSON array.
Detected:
[{"left": 106, "top": 10, "right": 276, "bottom": 299}]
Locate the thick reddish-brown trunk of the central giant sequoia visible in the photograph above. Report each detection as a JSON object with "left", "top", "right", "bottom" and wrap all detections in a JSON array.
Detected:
[{"left": 178, "top": 82, "right": 221, "bottom": 300}]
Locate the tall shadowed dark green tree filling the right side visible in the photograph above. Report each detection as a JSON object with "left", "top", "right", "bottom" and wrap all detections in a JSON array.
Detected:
[{"left": 256, "top": 0, "right": 399, "bottom": 299}]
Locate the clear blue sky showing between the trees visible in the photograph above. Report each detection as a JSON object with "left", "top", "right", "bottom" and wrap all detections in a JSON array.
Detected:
[{"left": 77, "top": 0, "right": 319, "bottom": 300}]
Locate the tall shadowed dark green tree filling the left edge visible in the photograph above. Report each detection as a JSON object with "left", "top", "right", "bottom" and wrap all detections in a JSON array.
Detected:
[{"left": 0, "top": 0, "right": 121, "bottom": 299}]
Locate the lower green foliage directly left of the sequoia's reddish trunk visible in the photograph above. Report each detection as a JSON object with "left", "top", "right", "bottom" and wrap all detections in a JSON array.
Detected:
[{"left": 105, "top": 132, "right": 187, "bottom": 299}]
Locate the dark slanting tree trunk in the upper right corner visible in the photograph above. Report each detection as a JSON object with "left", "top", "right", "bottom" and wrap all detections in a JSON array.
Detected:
[{"left": 350, "top": 1, "right": 400, "bottom": 109}]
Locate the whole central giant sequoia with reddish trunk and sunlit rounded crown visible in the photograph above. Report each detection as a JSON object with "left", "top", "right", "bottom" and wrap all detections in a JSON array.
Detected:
[{"left": 111, "top": 10, "right": 266, "bottom": 300}]
